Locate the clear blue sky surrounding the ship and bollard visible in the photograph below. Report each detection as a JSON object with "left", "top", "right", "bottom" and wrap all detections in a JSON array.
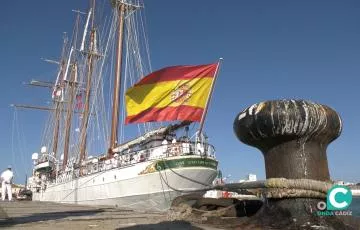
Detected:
[{"left": 0, "top": 0, "right": 360, "bottom": 183}]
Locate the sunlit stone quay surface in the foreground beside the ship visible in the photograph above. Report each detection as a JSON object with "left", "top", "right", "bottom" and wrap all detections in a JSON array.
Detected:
[{"left": 0, "top": 201, "right": 219, "bottom": 230}]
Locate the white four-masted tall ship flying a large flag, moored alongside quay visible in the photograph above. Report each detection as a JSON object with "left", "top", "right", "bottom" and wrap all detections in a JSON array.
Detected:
[{"left": 14, "top": 0, "right": 221, "bottom": 211}]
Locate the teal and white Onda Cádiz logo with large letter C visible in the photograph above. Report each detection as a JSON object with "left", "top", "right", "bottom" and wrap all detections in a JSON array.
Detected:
[{"left": 316, "top": 185, "right": 352, "bottom": 216}]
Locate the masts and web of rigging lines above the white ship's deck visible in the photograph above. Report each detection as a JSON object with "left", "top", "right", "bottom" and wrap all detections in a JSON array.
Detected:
[{"left": 14, "top": 0, "right": 156, "bottom": 169}]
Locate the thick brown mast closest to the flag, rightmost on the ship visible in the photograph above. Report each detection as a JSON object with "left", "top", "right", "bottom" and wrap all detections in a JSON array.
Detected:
[{"left": 108, "top": 1, "right": 125, "bottom": 156}]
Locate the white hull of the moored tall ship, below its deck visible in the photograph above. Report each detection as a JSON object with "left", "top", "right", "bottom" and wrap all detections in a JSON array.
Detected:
[{"left": 33, "top": 156, "right": 217, "bottom": 211}]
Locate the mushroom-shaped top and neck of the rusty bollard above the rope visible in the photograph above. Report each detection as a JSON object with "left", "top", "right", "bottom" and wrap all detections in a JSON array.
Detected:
[{"left": 234, "top": 100, "right": 342, "bottom": 181}]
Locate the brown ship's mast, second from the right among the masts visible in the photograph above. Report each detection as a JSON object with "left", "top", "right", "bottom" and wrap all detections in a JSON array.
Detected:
[{"left": 80, "top": 0, "right": 96, "bottom": 164}]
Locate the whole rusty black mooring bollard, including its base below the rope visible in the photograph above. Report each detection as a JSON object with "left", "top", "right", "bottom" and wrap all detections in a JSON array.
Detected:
[{"left": 234, "top": 100, "right": 358, "bottom": 229}]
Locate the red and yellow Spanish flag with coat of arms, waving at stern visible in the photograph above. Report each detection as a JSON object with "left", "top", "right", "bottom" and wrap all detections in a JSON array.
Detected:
[{"left": 125, "top": 63, "right": 218, "bottom": 124}]
